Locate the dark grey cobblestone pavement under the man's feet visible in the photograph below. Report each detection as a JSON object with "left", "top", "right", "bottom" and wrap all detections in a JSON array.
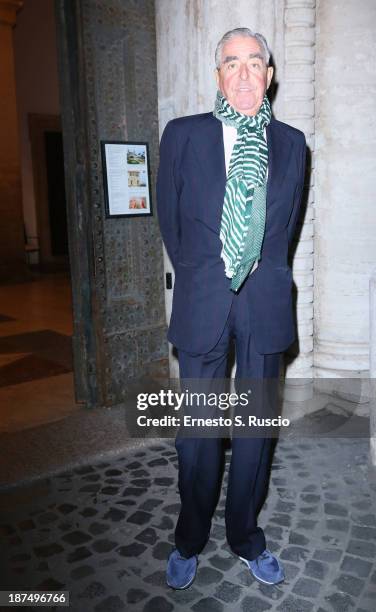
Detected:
[{"left": 0, "top": 439, "right": 376, "bottom": 612}]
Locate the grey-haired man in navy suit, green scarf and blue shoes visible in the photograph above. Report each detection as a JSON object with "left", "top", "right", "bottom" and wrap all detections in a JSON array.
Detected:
[{"left": 157, "top": 28, "right": 306, "bottom": 589}]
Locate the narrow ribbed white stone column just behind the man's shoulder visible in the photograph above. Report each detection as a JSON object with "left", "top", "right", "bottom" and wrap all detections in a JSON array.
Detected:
[{"left": 282, "top": 0, "right": 316, "bottom": 401}]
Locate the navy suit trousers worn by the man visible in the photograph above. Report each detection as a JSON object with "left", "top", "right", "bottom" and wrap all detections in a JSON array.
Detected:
[{"left": 175, "top": 290, "right": 281, "bottom": 560}]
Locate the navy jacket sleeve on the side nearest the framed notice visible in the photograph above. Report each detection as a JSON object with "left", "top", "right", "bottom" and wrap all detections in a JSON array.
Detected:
[{"left": 157, "top": 121, "right": 180, "bottom": 268}]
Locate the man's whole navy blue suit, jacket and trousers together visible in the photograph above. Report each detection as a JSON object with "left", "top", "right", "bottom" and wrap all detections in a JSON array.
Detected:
[{"left": 157, "top": 113, "right": 306, "bottom": 560}]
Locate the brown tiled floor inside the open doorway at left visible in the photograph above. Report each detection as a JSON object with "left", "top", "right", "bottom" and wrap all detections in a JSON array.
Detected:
[{"left": 0, "top": 273, "right": 78, "bottom": 432}]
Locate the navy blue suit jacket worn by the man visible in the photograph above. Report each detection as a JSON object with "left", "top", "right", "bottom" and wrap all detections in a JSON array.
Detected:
[{"left": 157, "top": 113, "right": 306, "bottom": 354}]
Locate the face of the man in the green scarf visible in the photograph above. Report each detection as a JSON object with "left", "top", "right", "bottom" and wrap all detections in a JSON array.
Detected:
[{"left": 216, "top": 36, "right": 273, "bottom": 116}]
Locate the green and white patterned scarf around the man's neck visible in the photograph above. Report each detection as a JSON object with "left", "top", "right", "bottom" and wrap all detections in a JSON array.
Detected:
[{"left": 213, "top": 91, "right": 271, "bottom": 292}]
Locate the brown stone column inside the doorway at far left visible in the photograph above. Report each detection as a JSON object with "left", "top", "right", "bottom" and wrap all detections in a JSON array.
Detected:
[{"left": 0, "top": 0, "right": 25, "bottom": 280}]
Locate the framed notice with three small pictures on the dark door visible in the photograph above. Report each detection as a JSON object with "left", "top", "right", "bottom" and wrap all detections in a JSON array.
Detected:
[{"left": 101, "top": 140, "right": 153, "bottom": 217}]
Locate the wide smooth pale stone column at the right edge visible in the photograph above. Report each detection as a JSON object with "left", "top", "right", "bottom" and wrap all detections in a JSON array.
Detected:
[{"left": 314, "top": 0, "right": 376, "bottom": 378}]
